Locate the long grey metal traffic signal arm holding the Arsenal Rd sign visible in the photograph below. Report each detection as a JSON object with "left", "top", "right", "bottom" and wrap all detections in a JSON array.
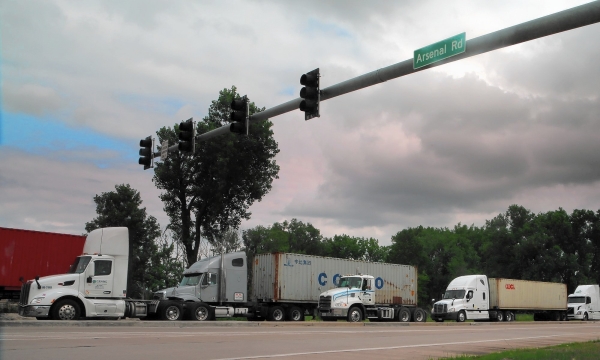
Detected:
[{"left": 155, "top": 0, "right": 600, "bottom": 156}]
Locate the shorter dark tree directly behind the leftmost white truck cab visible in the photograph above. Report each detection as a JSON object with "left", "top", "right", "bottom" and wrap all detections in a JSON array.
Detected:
[{"left": 85, "top": 184, "right": 170, "bottom": 298}]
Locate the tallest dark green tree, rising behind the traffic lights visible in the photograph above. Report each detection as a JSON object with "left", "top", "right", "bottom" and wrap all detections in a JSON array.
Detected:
[{"left": 153, "top": 86, "right": 279, "bottom": 265}]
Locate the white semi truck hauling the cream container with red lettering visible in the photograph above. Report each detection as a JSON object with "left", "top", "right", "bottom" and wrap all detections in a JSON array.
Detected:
[{"left": 431, "top": 275, "right": 567, "bottom": 322}]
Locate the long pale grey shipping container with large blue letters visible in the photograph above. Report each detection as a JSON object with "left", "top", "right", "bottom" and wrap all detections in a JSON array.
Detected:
[{"left": 252, "top": 253, "right": 417, "bottom": 305}]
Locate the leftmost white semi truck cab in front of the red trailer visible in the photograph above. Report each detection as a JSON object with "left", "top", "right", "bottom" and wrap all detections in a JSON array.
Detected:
[{"left": 19, "top": 228, "right": 146, "bottom": 320}]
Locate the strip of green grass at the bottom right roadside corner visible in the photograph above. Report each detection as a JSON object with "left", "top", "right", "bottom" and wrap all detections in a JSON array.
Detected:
[{"left": 438, "top": 340, "right": 600, "bottom": 360}]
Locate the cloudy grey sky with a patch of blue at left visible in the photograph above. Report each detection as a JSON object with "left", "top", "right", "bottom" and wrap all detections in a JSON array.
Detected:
[{"left": 0, "top": 0, "right": 600, "bottom": 245}]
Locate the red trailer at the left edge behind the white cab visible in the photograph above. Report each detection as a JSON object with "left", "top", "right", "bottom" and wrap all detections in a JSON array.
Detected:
[{"left": 0, "top": 227, "right": 85, "bottom": 300}]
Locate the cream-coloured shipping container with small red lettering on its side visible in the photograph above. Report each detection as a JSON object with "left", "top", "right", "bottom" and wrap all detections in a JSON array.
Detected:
[{"left": 488, "top": 278, "right": 567, "bottom": 310}]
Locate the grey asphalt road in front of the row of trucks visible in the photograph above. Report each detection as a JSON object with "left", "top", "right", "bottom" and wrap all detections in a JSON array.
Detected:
[{"left": 0, "top": 321, "right": 600, "bottom": 360}]
